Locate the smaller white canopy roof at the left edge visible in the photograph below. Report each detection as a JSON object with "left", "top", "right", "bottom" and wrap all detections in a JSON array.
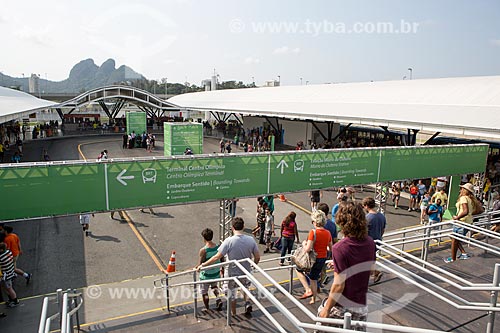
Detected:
[{"left": 0, "top": 87, "right": 57, "bottom": 124}]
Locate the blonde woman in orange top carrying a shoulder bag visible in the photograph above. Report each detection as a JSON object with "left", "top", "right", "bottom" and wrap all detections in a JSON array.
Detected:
[{"left": 297, "top": 210, "right": 333, "bottom": 304}]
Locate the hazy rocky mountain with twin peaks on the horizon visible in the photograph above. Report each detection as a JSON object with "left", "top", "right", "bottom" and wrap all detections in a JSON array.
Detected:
[{"left": 0, "top": 59, "right": 145, "bottom": 93}]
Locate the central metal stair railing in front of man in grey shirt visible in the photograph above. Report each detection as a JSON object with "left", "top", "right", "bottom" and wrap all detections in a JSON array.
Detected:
[{"left": 154, "top": 256, "right": 444, "bottom": 333}]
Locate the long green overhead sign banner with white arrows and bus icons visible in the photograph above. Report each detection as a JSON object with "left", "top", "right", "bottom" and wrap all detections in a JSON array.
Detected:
[{"left": 0, "top": 145, "right": 488, "bottom": 220}]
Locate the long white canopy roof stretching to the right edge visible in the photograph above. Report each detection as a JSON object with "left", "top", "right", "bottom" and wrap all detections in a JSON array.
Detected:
[{"left": 169, "top": 76, "right": 500, "bottom": 139}]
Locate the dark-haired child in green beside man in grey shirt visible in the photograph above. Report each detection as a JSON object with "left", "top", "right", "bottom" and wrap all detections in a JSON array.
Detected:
[{"left": 198, "top": 228, "right": 224, "bottom": 311}]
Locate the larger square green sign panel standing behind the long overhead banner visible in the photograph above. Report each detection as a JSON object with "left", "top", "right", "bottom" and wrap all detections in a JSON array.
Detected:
[{"left": 163, "top": 122, "right": 203, "bottom": 156}]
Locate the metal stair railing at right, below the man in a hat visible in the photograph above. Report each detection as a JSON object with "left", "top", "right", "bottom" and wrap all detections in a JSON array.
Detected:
[{"left": 377, "top": 212, "right": 500, "bottom": 333}]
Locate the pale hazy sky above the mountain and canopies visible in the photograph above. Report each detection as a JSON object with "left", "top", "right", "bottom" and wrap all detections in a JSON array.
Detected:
[{"left": 0, "top": 0, "right": 500, "bottom": 85}]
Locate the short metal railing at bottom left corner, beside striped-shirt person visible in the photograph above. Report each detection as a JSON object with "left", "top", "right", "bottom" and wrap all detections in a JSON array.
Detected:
[{"left": 38, "top": 289, "right": 83, "bottom": 333}]
